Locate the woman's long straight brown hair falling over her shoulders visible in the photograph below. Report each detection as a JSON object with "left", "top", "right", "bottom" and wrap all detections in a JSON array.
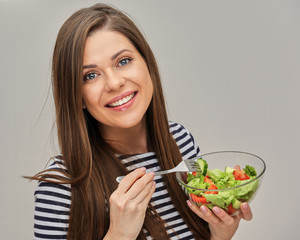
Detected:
[{"left": 32, "top": 4, "right": 210, "bottom": 240}]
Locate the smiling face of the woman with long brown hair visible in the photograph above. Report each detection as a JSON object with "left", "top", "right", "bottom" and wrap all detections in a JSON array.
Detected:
[{"left": 83, "top": 30, "right": 153, "bottom": 131}]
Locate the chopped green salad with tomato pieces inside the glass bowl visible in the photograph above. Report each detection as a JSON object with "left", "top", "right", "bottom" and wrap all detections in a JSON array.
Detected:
[{"left": 186, "top": 159, "right": 259, "bottom": 215}]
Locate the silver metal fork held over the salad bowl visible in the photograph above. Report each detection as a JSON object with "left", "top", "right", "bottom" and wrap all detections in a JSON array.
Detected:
[{"left": 116, "top": 157, "right": 201, "bottom": 183}]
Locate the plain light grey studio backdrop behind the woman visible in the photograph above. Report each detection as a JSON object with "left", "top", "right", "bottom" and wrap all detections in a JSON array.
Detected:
[{"left": 0, "top": 0, "right": 300, "bottom": 240}]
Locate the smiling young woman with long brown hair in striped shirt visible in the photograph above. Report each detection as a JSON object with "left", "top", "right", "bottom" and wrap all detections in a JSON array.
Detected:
[{"left": 32, "top": 4, "right": 252, "bottom": 240}]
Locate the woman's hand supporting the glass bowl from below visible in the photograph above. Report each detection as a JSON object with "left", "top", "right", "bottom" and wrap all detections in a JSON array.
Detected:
[{"left": 187, "top": 201, "right": 252, "bottom": 240}]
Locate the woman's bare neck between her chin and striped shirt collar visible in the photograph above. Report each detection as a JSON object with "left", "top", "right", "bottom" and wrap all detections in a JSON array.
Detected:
[{"left": 99, "top": 118, "right": 150, "bottom": 155}]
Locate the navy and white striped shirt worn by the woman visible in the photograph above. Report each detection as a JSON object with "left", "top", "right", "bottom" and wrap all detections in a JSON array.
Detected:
[{"left": 34, "top": 122, "right": 200, "bottom": 240}]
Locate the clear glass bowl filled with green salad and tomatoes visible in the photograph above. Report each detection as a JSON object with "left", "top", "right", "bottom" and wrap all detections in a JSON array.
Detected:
[{"left": 176, "top": 151, "right": 266, "bottom": 216}]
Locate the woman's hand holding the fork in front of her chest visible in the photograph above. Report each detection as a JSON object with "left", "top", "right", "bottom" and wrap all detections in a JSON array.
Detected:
[{"left": 104, "top": 168, "right": 155, "bottom": 240}]
